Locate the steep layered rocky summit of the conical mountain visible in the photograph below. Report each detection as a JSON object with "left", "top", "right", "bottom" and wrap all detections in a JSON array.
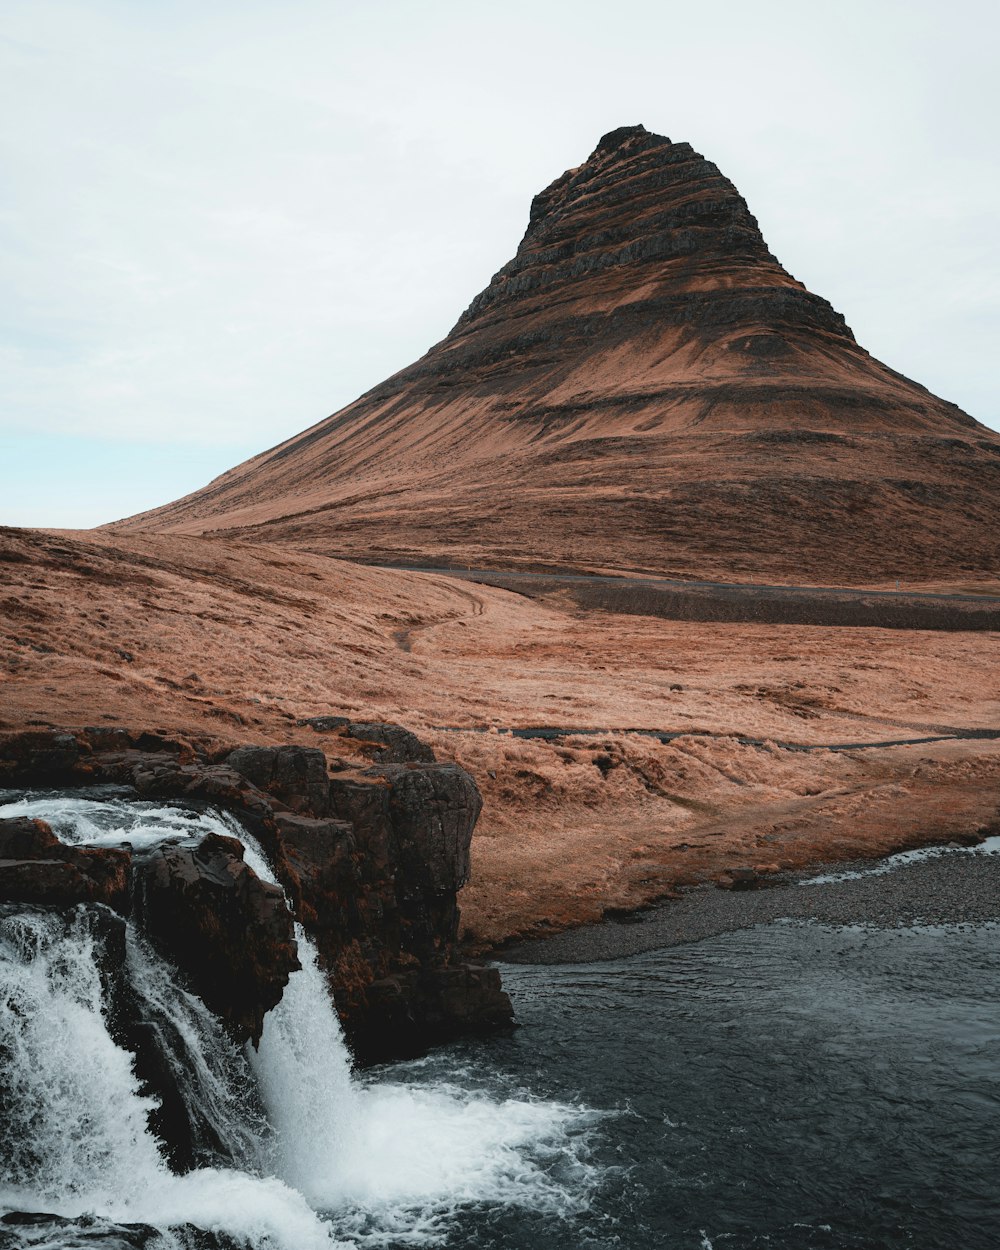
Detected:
[{"left": 456, "top": 126, "right": 853, "bottom": 339}]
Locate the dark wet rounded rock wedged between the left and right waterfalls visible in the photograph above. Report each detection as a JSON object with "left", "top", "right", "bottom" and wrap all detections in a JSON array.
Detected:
[{"left": 135, "top": 834, "right": 300, "bottom": 1043}]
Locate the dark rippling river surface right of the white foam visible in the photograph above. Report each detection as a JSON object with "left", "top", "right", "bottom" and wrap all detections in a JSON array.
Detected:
[{"left": 425, "top": 923, "right": 1000, "bottom": 1250}]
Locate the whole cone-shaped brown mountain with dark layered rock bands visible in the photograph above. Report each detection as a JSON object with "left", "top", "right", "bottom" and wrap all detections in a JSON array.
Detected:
[{"left": 116, "top": 126, "right": 1000, "bottom": 584}]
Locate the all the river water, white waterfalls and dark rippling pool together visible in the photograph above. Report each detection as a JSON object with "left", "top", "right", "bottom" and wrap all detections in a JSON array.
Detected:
[{"left": 0, "top": 795, "right": 1000, "bottom": 1250}]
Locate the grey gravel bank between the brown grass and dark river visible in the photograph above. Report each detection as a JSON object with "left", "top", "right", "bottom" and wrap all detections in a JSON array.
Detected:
[{"left": 496, "top": 838, "right": 1000, "bottom": 964}]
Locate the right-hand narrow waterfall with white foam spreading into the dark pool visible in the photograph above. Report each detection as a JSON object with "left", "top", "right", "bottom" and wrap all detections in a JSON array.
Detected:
[{"left": 240, "top": 818, "right": 596, "bottom": 1245}]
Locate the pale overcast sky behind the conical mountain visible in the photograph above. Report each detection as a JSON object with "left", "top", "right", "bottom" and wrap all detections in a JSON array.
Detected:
[{"left": 0, "top": 0, "right": 1000, "bottom": 526}]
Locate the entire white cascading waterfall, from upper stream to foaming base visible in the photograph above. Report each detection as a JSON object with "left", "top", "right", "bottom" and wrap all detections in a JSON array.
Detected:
[{"left": 0, "top": 795, "right": 594, "bottom": 1250}]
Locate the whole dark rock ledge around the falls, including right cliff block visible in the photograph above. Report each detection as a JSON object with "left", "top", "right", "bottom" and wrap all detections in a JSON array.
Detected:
[{"left": 0, "top": 726, "right": 513, "bottom": 1063}]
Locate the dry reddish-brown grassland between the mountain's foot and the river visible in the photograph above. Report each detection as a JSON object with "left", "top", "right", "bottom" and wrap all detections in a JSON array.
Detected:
[{"left": 0, "top": 531, "right": 1000, "bottom": 944}]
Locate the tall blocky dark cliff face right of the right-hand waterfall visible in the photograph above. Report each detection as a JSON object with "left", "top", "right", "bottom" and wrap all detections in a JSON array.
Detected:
[{"left": 285, "top": 763, "right": 514, "bottom": 1063}]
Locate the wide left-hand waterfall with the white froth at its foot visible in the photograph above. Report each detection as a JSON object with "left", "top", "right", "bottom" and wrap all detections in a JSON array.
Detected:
[{"left": 0, "top": 911, "right": 345, "bottom": 1250}]
